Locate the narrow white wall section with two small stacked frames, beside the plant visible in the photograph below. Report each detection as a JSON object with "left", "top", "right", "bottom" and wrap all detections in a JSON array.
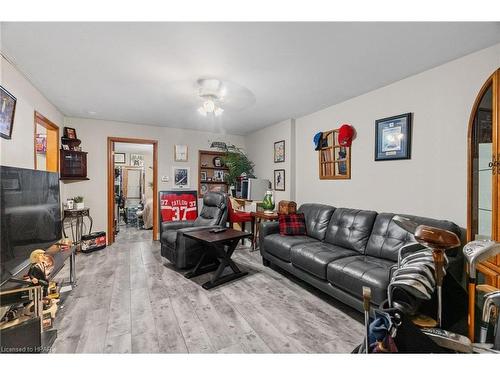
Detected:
[{"left": 245, "top": 120, "right": 295, "bottom": 202}]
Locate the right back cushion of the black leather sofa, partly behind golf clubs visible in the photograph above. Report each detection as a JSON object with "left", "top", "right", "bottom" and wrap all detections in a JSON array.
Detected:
[{"left": 366, "top": 213, "right": 461, "bottom": 262}]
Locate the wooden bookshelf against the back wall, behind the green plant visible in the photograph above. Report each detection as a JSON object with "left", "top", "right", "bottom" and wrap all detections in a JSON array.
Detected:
[{"left": 198, "top": 150, "right": 229, "bottom": 197}]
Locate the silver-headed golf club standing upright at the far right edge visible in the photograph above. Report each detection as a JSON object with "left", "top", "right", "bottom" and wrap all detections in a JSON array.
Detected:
[{"left": 463, "top": 240, "right": 500, "bottom": 341}]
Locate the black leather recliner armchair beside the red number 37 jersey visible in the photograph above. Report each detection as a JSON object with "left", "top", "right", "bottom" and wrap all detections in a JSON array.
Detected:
[{"left": 160, "top": 192, "right": 227, "bottom": 269}]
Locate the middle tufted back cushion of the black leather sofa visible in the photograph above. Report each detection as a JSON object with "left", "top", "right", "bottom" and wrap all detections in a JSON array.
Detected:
[{"left": 325, "top": 208, "right": 377, "bottom": 254}]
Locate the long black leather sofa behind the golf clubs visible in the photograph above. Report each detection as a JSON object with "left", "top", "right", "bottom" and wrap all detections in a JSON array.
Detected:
[{"left": 259, "top": 204, "right": 463, "bottom": 311}]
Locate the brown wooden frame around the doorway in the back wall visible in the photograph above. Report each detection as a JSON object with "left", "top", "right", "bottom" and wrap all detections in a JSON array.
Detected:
[{"left": 108, "top": 137, "right": 159, "bottom": 245}]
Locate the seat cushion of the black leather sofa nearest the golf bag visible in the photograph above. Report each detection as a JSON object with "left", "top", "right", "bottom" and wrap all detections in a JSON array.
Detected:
[{"left": 326, "top": 255, "right": 395, "bottom": 305}]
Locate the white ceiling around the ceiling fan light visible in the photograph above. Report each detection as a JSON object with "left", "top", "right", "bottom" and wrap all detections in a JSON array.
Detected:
[{"left": 0, "top": 22, "right": 500, "bottom": 134}]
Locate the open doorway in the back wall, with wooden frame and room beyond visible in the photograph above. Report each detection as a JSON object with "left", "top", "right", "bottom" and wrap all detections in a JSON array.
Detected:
[{"left": 108, "top": 137, "right": 158, "bottom": 244}]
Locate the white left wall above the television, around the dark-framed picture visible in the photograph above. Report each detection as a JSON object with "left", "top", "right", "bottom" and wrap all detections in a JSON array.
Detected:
[{"left": 0, "top": 56, "right": 63, "bottom": 169}]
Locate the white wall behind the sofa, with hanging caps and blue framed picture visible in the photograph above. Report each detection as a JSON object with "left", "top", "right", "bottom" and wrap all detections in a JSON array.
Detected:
[{"left": 290, "top": 44, "right": 500, "bottom": 227}]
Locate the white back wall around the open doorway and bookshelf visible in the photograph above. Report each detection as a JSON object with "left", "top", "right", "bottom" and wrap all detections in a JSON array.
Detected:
[{"left": 63, "top": 118, "right": 245, "bottom": 235}]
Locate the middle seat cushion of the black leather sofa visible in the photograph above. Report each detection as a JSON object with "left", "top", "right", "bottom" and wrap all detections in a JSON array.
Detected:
[{"left": 290, "top": 242, "right": 358, "bottom": 280}]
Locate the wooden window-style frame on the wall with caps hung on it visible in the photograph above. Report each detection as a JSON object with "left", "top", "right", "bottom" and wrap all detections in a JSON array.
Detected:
[{"left": 318, "top": 129, "right": 351, "bottom": 180}]
